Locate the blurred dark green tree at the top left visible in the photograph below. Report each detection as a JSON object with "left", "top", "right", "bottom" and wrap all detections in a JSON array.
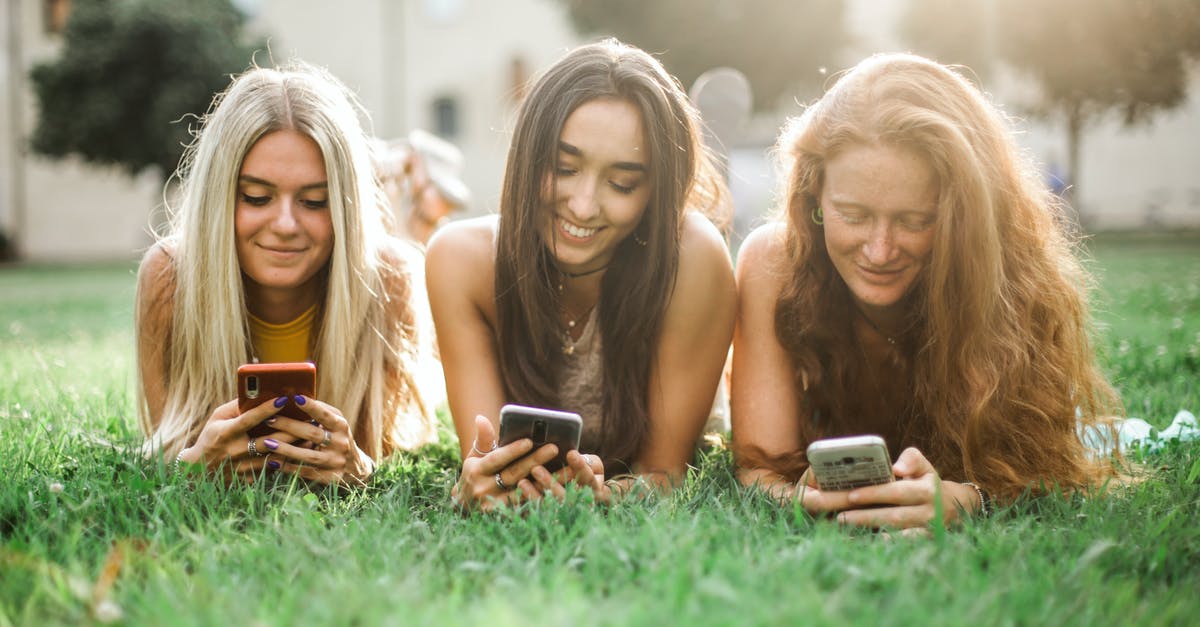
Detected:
[{"left": 30, "top": 0, "right": 260, "bottom": 175}]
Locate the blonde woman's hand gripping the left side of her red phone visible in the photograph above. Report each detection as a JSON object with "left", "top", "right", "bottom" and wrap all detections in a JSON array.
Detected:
[{"left": 179, "top": 399, "right": 286, "bottom": 476}]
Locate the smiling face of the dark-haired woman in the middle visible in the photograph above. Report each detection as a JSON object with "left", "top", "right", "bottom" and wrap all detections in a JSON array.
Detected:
[{"left": 541, "top": 98, "right": 650, "bottom": 273}]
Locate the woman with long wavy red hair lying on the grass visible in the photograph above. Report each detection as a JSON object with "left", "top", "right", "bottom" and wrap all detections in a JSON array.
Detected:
[{"left": 732, "top": 54, "right": 1118, "bottom": 529}]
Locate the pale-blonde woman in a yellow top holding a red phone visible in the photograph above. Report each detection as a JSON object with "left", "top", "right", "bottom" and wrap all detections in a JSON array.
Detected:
[{"left": 136, "top": 62, "right": 434, "bottom": 484}]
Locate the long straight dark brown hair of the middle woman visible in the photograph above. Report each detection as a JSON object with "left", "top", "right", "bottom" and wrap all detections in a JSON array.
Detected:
[{"left": 496, "top": 40, "right": 725, "bottom": 466}]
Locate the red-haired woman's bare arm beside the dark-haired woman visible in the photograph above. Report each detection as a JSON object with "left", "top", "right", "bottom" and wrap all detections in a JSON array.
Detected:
[{"left": 730, "top": 225, "right": 804, "bottom": 500}]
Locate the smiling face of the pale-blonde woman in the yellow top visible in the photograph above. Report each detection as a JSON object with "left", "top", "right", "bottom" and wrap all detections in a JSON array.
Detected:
[{"left": 234, "top": 130, "right": 334, "bottom": 301}]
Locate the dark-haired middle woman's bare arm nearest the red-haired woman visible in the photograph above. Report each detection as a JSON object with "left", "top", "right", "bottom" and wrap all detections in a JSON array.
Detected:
[{"left": 634, "top": 211, "right": 737, "bottom": 486}]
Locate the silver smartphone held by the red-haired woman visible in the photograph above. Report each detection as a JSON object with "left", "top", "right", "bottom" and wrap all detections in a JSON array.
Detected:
[{"left": 809, "top": 435, "right": 895, "bottom": 491}]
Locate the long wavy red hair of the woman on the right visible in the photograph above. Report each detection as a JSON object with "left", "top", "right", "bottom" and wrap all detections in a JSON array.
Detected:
[{"left": 775, "top": 54, "right": 1120, "bottom": 496}]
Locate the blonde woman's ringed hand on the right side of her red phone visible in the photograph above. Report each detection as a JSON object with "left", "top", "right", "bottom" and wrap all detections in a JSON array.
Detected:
[{"left": 256, "top": 395, "right": 374, "bottom": 485}]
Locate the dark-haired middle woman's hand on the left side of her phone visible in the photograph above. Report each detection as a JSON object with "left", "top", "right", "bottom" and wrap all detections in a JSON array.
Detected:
[{"left": 450, "top": 416, "right": 558, "bottom": 512}]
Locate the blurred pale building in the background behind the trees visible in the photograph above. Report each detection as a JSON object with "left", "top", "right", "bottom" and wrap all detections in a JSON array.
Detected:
[{"left": 0, "top": 0, "right": 1200, "bottom": 259}]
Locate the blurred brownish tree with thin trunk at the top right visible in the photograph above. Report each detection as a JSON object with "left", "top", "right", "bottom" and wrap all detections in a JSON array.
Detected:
[{"left": 902, "top": 0, "right": 1200, "bottom": 202}]
